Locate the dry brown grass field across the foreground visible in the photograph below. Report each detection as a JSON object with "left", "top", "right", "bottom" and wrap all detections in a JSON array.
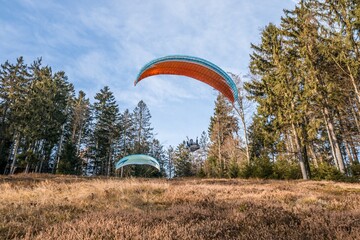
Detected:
[{"left": 0, "top": 175, "right": 360, "bottom": 240}]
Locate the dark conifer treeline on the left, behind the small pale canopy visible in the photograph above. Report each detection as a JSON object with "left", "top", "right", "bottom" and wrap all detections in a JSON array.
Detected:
[{"left": 0, "top": 57, "right": 165, "bottom": 176}]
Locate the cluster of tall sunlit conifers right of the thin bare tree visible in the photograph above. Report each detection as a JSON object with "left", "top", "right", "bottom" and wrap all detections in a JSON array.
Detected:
[{"left": 245, "top": 0, "right": 360, "bottom": 179}]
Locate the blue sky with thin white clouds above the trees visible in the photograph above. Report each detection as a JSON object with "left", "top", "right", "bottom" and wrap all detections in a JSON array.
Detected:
[{"left": 0, "top": 0, "right": 296, "bottom": 146}]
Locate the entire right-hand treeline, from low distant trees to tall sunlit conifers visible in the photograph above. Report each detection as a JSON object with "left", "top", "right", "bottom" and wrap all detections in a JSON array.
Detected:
[{"left": 171, "top": 0, "right": 360, "bottom": 179}]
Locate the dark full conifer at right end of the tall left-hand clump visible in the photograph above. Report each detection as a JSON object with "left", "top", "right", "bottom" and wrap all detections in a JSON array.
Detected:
[{"left": 27, "top": 62, "right": 74, "bottom": 172}]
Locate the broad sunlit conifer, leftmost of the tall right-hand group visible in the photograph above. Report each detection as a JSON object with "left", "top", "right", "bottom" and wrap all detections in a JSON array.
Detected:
[{"left": 246, "top": 24, "right": 310, "bottom": 179}]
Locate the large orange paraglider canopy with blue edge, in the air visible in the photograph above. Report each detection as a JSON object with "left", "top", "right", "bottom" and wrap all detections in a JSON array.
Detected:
[{"left": 134, "top": 55, "right": 238, "bottom": 103}]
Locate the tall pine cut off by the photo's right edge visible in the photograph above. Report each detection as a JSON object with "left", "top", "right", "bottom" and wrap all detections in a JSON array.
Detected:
[{"left": 303, "top": 0, "right": 360, "bottom": 169}]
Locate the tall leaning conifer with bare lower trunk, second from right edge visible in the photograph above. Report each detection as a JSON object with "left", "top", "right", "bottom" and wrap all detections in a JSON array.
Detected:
[{"left": 282, "top": 2, "right": 345, "bottom": 173}]
